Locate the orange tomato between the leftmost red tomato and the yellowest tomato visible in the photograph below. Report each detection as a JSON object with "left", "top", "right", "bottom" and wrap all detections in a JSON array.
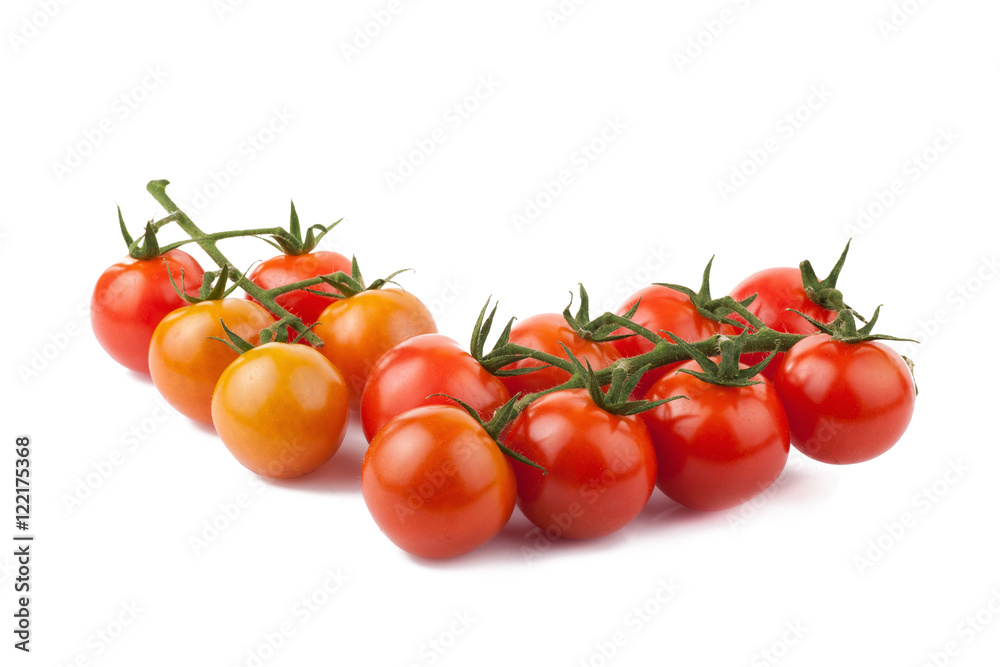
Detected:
[{"left": 149, "top": 299, "right": 274, "bottom": 424}]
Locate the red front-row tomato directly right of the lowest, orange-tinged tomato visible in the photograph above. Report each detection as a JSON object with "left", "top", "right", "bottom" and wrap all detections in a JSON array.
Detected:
[{"left": 504, "top": 389, "right": 656, "bottom": 539}]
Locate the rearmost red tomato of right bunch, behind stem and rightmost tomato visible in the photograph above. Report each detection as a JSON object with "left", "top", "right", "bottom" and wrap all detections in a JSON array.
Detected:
[{"left": 726, "top": 267, "right": 837, "bottom": 382}]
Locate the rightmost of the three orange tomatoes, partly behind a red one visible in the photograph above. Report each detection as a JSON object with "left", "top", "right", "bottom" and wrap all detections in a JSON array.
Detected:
[{"left": 313, "top": 289, "right": 437, "bottom": 408}]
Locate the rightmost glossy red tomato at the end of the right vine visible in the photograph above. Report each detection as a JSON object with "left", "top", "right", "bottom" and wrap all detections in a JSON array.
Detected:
[{"left": 774, "top": 334, "right": 916, "bottom": 464}]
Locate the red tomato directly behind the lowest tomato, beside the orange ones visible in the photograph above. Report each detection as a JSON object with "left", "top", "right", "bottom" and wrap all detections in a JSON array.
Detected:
[{"left": 361, "top": 334, "right": 510, "bottom": 442}]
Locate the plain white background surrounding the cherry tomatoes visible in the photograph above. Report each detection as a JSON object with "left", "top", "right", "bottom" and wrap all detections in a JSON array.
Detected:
[{"left": 0, "top": 0, "right": 1000, "bottom": 667}]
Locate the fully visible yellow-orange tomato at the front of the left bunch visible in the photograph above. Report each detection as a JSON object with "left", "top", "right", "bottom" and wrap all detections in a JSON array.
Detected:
[{"left": 212, "top": 343, "right": 350, "bottom": 478}]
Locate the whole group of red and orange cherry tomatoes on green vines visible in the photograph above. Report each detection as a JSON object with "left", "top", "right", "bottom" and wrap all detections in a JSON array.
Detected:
[{"left": 92, "top": 182, "right": 916, "bottom": 558}]
